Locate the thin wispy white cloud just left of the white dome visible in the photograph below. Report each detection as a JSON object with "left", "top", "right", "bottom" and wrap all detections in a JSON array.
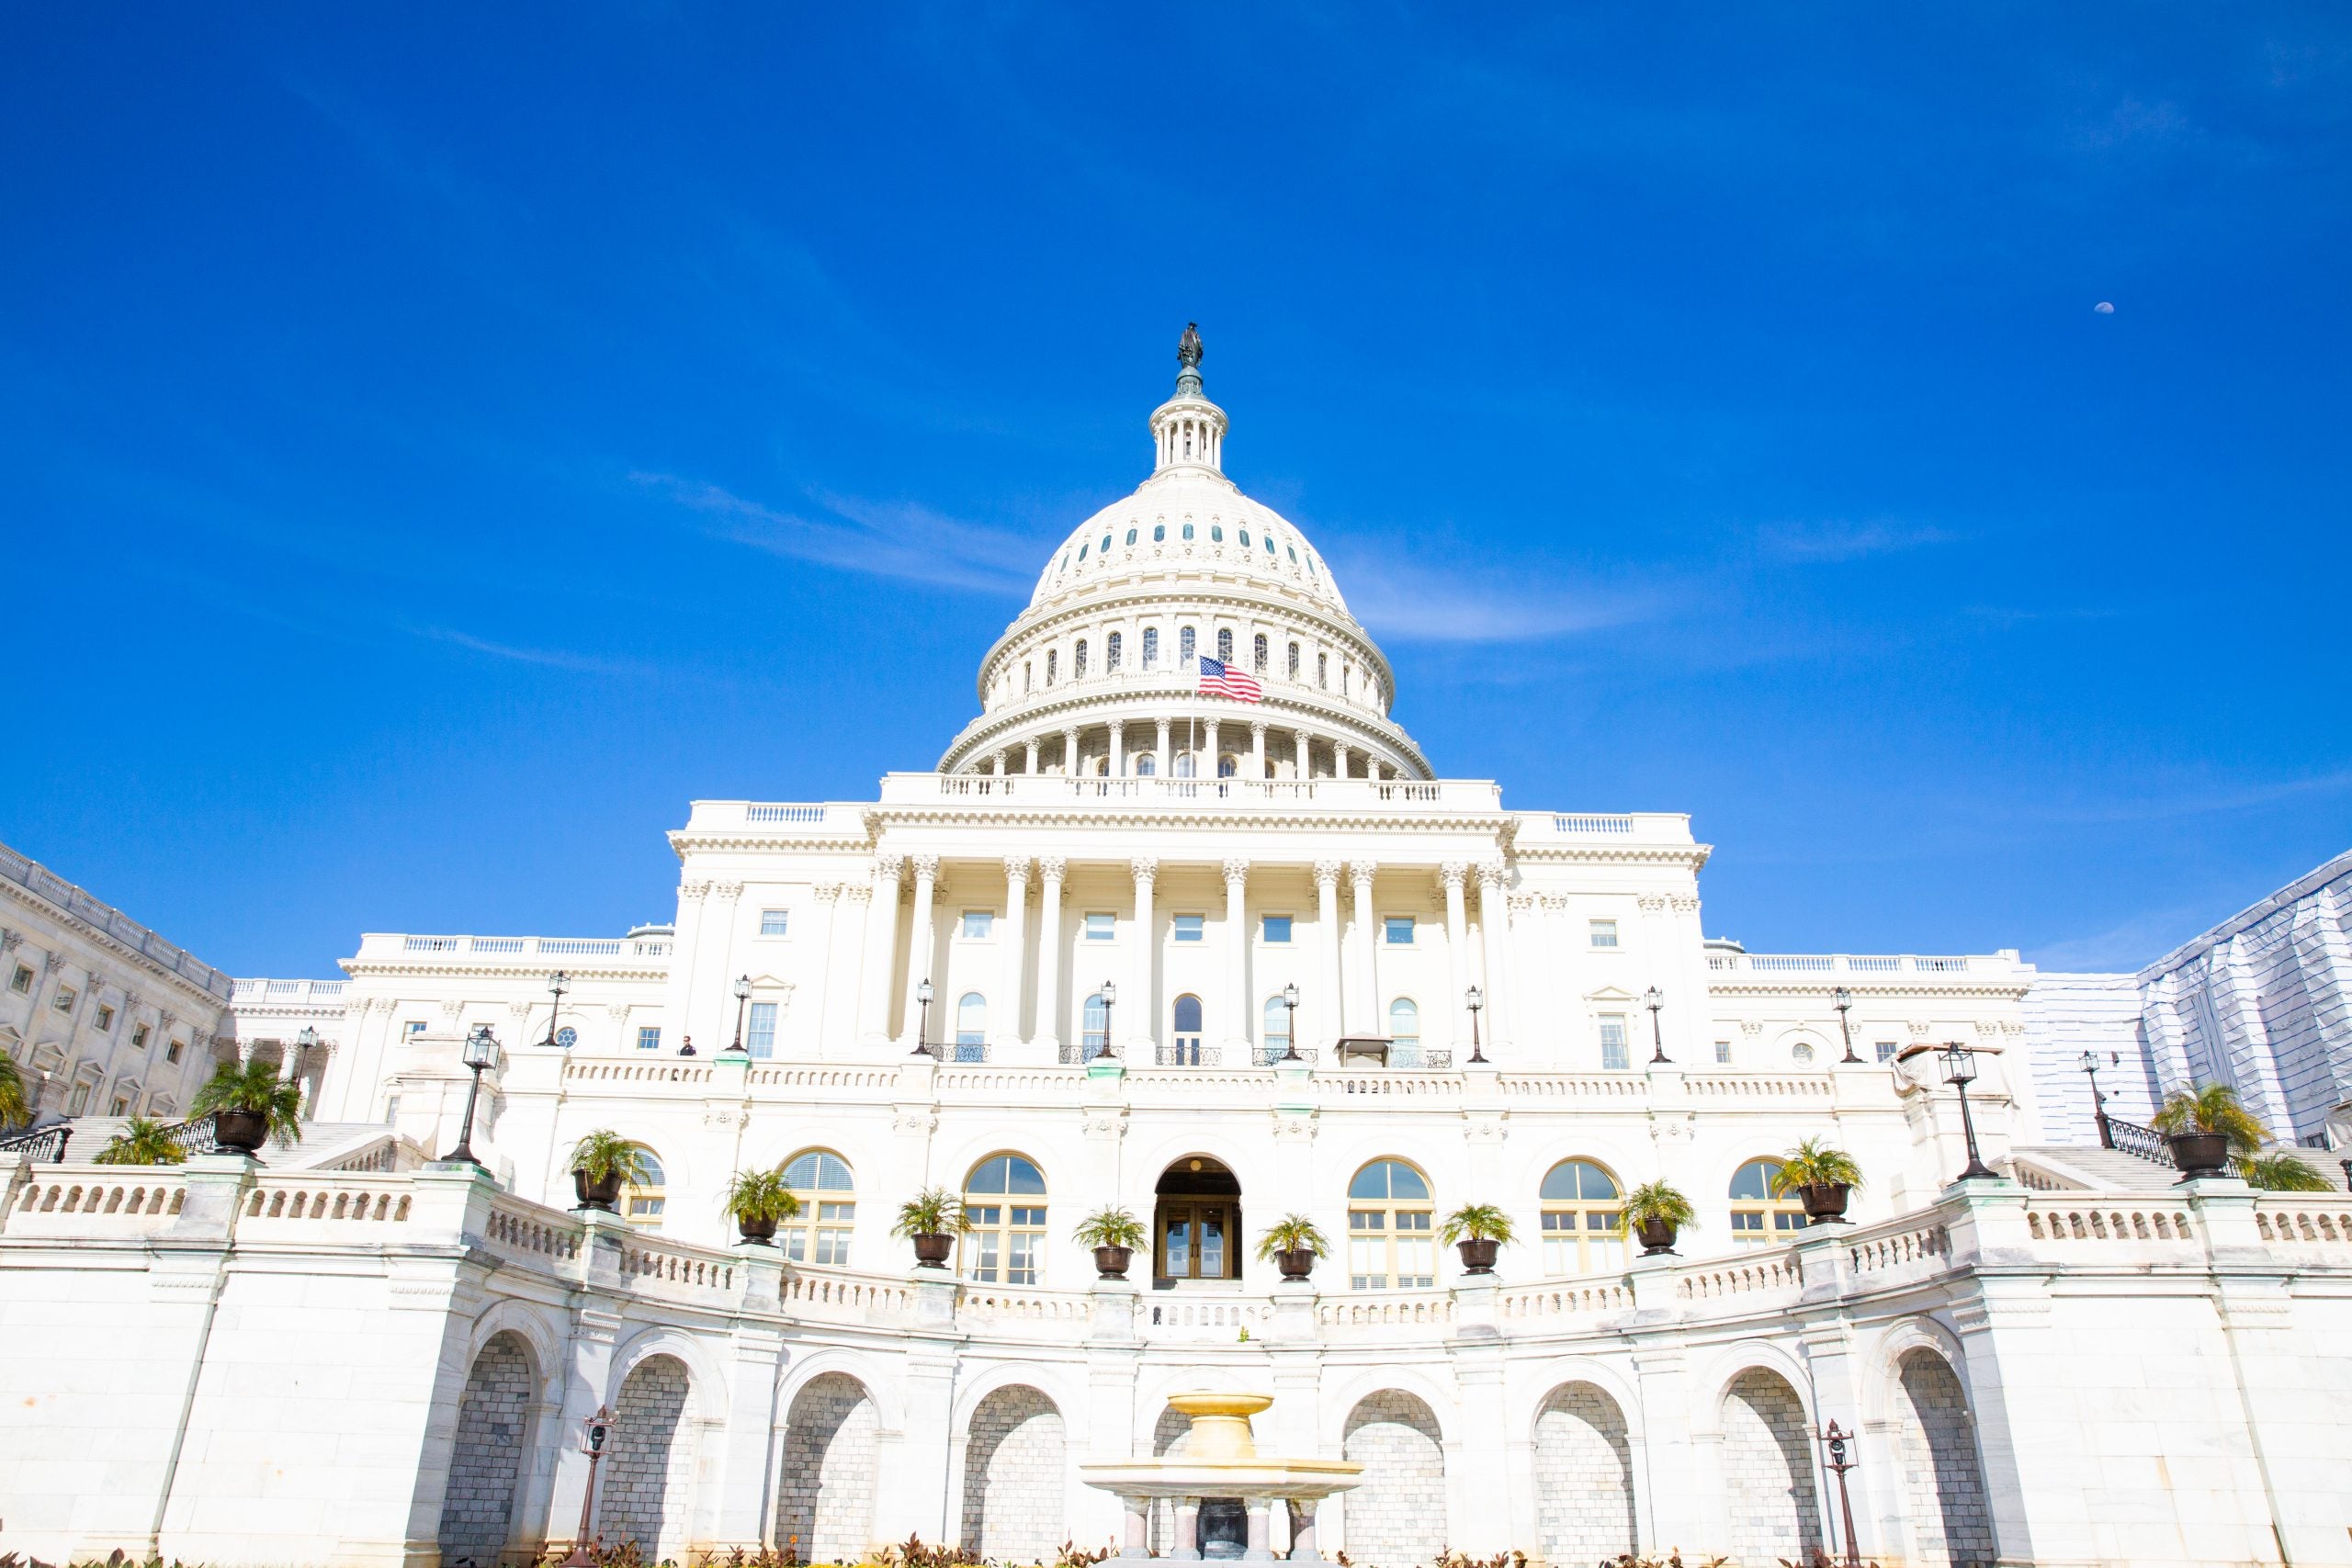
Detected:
[{"left": 630, "top": 472, "right": 1046, "bottom": 597}]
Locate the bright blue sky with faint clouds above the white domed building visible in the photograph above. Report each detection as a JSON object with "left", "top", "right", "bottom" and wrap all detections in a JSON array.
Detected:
[{"left": 0, "top": 5, "right": 2352, "bottom": 976}]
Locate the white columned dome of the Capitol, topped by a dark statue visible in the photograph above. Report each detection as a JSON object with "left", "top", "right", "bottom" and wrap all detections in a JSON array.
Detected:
[{"left": 938, "top": 332, "right": 1432, "bottom": 781}]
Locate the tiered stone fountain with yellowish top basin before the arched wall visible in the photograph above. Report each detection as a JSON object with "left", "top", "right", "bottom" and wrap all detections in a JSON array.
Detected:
[{"left": 1077, "top": 1394, "right": 1364, "bottom": 1563}]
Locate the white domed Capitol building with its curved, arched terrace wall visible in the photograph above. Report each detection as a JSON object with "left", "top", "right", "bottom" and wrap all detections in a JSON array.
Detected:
[{"left": 0, "top": 333, "right": 2352, "bottom": 1568}]
